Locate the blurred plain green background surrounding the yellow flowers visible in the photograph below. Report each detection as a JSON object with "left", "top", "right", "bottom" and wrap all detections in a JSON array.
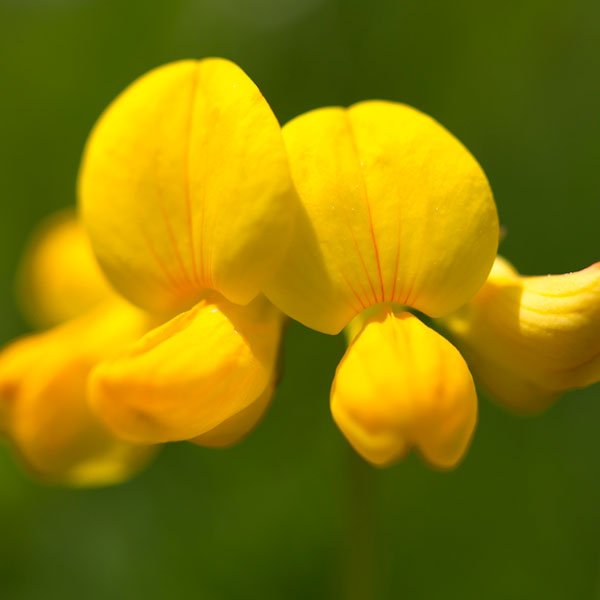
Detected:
[{"left": 0, "top": 0, "right": 600, "bottom": 600}]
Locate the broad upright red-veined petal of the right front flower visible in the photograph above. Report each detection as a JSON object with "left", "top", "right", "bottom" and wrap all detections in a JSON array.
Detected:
[{"left": 266, "top": 101, "right": 498, "bottom": 333}]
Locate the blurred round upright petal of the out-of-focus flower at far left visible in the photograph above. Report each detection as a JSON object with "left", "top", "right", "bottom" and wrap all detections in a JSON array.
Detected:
[{"left": 18, "top": 210, "right": 112, "bottom": 327}]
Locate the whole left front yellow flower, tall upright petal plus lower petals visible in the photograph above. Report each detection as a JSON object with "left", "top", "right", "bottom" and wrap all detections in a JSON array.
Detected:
[{"left": 79, "top": 59, "right": 297, "bottom": 446}]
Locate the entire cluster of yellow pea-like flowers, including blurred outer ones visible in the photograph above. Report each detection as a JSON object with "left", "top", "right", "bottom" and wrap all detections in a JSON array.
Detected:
[{"left": 0, "top": 59, "right": 600, "bottom": 485}]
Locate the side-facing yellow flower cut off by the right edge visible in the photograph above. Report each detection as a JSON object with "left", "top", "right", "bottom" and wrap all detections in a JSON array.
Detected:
[{"left": 444, "top": 257, "right": 600, "bottom": 412}]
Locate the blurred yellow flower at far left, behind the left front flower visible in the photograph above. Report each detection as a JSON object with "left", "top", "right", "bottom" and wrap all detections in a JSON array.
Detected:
[{"left": 0, "top": 212, "right": 154, "bottom": 485}]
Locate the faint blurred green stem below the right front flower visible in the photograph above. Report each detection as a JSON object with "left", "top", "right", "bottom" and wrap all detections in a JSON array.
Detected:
[{"left": 343, "top": 446, "right": 379, "bottom": 600}]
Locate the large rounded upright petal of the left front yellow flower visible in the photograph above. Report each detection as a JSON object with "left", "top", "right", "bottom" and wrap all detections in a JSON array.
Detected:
[{"left": 79, "top": 59, "right": 297, "bottom": 312}]
